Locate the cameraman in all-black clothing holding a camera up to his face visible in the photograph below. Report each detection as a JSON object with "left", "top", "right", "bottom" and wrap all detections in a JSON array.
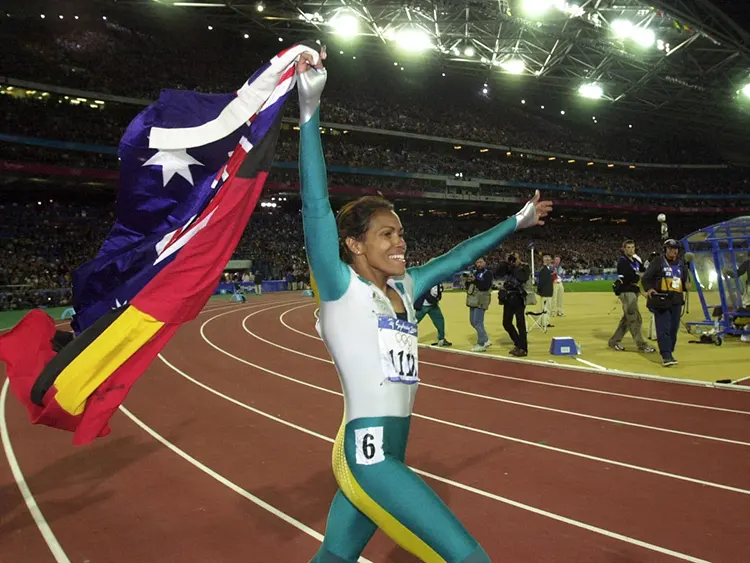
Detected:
[{"left": 495, "top": 252, "right": 531, "bottom": 357}]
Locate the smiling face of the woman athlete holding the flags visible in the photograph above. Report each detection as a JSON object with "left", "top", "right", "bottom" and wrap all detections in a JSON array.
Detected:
[{"left": 355, "top": 209, "right": 406, "bottom": 277}]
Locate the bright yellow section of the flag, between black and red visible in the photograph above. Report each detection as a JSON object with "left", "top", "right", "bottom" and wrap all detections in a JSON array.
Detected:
[{"left": 55, "top": 305, "right": 164, "bottom": 415}]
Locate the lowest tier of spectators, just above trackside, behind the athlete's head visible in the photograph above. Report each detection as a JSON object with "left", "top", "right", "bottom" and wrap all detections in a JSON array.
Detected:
[{"left": 0, "top": 200, "right": 716, "bottom": 310}]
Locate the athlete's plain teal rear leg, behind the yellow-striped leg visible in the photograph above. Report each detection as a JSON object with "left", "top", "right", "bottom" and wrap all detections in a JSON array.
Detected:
[{"left": 310, "top": 490, "right": 377, "bottom": 563}]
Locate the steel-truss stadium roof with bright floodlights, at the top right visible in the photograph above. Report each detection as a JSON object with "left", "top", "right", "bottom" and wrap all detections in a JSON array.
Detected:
[{"left": 94, "top": 0, "right": 750, "bottom": 145}]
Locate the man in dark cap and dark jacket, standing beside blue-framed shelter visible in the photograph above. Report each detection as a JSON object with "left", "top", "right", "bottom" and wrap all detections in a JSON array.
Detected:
[{"left": 641, "top": 239, "right": 690, "bottom": 367}]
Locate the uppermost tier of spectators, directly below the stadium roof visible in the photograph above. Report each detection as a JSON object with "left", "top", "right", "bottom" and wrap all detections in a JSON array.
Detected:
[{"left": 3, "top": 17, "right": 736, "bottom": 163}]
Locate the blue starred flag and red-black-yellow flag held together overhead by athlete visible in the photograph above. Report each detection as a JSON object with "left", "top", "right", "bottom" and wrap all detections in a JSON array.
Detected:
[{"left": 0, "top": 42, "right": 320, "bottom": 445}]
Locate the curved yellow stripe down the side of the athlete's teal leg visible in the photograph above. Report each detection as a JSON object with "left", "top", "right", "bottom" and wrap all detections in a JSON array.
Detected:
[{"left": 333, "top": 424, "right": 446, "bottom": 563}]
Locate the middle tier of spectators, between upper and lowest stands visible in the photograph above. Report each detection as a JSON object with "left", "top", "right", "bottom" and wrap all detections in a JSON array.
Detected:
[{"left": 0, "top": 95, "right": 750, "bottom": 210}]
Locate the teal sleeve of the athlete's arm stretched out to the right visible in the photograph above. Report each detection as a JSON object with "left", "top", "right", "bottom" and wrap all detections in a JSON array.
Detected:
[{"left": 408, "top": 216, "right": 516, "bottom": 299}]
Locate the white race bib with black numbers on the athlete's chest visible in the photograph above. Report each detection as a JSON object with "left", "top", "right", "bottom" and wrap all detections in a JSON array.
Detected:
[{"left": 378, "top": 315, "right": 419, "bottom": 384}]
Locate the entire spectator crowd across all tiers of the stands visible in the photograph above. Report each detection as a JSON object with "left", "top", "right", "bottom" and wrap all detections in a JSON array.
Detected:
[{"left": 0, "top": 12, "right": 750, "bottom": 310}]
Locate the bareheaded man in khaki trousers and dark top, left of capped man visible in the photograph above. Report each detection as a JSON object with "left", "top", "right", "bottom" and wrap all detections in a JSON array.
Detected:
[{"left": 608, "top": 240, "right": 656, "bottom": 354}]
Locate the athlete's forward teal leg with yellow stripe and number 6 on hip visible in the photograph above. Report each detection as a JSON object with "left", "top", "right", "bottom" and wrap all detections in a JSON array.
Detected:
[{"left": 334, "top": 417, "right": 490, "bottom": 563}]
